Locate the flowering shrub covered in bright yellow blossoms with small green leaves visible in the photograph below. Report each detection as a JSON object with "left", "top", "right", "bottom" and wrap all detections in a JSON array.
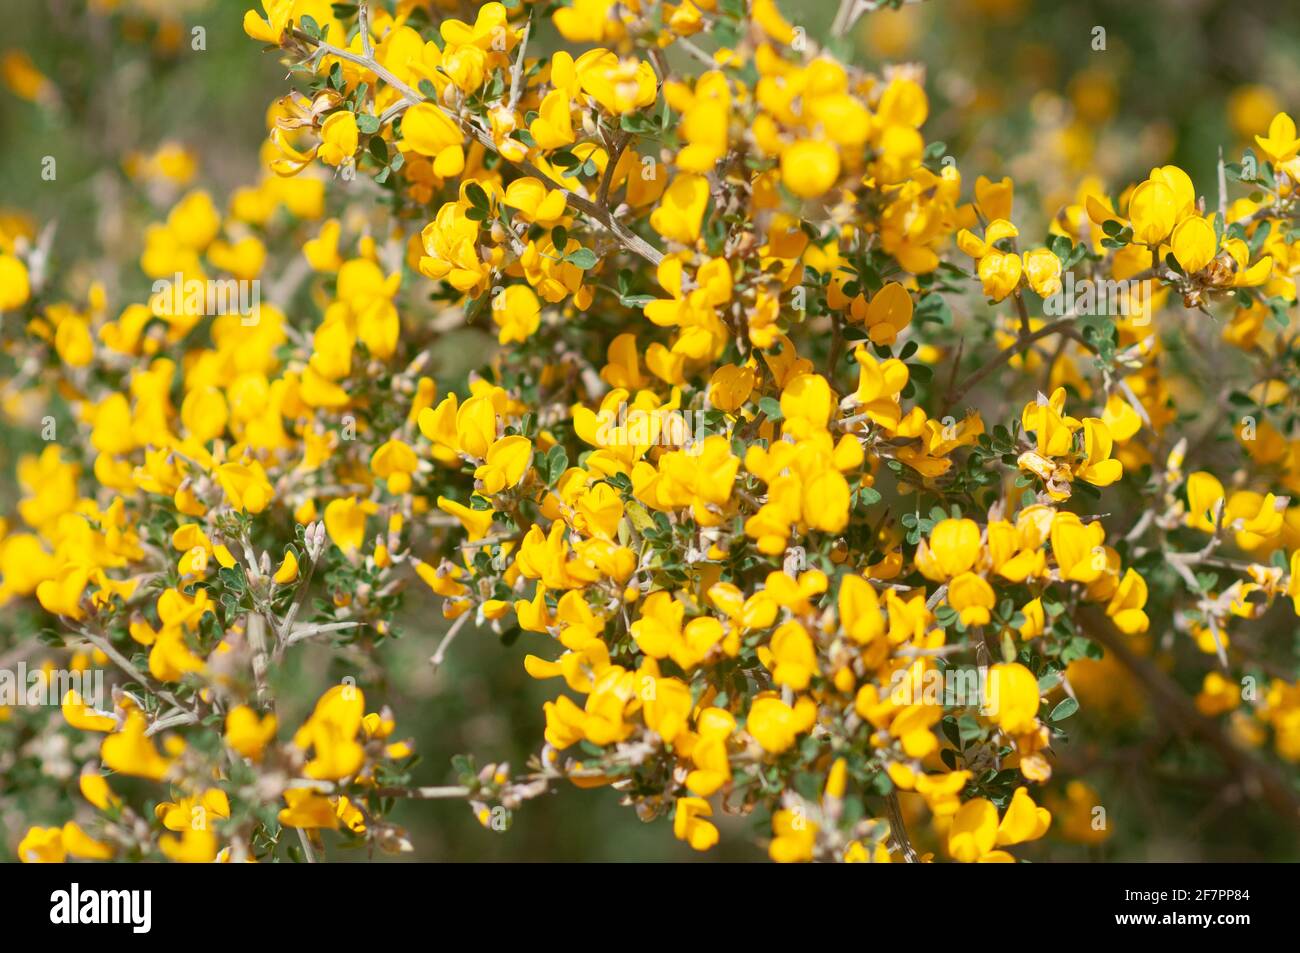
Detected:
[{"left": 0, "top": 0, "right": 1300, "bottom": 862}]
